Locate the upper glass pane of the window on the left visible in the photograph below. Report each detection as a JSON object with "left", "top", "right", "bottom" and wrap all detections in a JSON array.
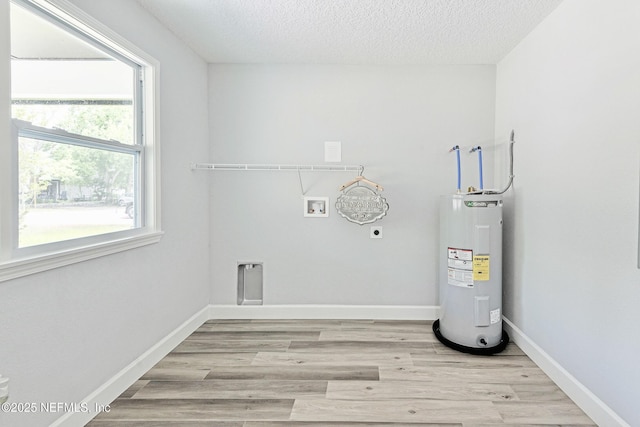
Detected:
[{"left": 11, "top": 4, "right": 137, "bottom": 144}]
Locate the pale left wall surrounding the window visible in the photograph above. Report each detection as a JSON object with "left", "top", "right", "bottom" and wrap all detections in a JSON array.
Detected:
[{"left": 0, "top": 0, "right": 210, "bottom": 427}]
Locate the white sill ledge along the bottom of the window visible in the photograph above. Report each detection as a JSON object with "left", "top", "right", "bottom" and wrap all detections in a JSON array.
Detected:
[{"left": 0, "top": 231, "right": 164, "bottom": 282}]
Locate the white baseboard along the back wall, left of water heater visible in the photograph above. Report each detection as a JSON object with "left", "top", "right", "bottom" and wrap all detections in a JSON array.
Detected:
[{"left": 209, "top": 304, "right": 438, "bottom": 320}]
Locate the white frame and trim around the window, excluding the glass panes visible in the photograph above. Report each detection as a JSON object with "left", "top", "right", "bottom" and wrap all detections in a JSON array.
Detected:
[{"left": 0, "top": 0, "right": 163, "bottom": 282}]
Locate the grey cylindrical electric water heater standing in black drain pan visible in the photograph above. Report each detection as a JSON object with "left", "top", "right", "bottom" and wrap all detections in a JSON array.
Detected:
[{"left": 433, "top": 193, "right": 509, "bottom": 354}]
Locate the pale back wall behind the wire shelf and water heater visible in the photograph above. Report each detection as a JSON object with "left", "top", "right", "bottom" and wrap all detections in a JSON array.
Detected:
[{"left": 208, "top": 65, "right": 495, "bottom": 306}]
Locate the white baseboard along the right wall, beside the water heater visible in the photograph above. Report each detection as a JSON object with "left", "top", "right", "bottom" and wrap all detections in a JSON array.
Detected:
[{"left": 503, "top": 317, "right": 630, "bottom": 427}]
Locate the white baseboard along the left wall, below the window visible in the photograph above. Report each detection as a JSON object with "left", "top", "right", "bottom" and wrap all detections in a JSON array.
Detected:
[{"left": 50, "top": 307, "right": 209, "bottom": 427}]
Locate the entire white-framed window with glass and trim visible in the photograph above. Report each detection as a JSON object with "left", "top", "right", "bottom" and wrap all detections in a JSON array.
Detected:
[{"left": 0, "top": 0, "right": 160, "bottom": 280}]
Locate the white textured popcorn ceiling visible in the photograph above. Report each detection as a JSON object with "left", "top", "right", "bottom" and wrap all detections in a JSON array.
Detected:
[{"left": 138, "top": 0, "right": 562, "bottom": 64}]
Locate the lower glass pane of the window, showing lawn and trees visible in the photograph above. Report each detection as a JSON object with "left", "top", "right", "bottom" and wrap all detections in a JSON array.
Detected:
[{"left": 18, "top": 132, "right": 136, "bottom": 248}]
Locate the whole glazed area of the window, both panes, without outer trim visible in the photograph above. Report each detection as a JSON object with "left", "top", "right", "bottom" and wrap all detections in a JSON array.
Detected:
[{"left": 10, "top": 1, "right": 144, "bottom": 248}]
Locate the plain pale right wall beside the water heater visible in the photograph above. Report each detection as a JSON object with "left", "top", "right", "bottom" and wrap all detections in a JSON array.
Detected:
[{"left": 496, "top": 0, "right": 640, "bottom": 426}]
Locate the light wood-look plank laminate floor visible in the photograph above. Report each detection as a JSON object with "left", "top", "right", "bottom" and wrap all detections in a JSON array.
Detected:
[{"left": 89, "top": 320, "right": 595, "bottom": 427}]
